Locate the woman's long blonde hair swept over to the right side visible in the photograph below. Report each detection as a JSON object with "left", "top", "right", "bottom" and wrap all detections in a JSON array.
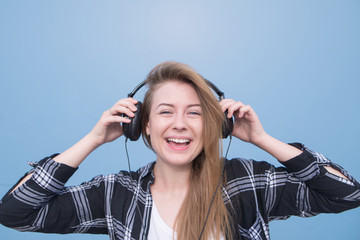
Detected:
[{"left": 141, "top": 62, "right": 231, "bottom": 240}]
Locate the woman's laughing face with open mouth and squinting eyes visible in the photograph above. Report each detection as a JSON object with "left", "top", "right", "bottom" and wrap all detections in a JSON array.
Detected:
[{"left": 146, "top": 80, "right": 203, "bottom": 168}]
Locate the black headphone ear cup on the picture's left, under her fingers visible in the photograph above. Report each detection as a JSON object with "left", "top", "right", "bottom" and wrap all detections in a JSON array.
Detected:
[{"left": 122, "top": 101, "right": 142, "bottom": 141}]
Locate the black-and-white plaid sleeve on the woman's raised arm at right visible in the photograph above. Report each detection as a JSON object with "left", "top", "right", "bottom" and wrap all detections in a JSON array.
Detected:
[{"left": 263, "top": 143, "right": 360, "bottom": 220}]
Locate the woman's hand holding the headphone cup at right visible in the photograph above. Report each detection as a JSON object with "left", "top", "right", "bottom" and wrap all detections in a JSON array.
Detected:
[{"left": 220, "top": 99, "right": 266, "bottom": 145}]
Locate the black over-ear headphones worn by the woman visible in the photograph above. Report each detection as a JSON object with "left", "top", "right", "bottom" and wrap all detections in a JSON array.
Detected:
[{"left": 122, "top": 79, "right": 234, "bottom": 141}]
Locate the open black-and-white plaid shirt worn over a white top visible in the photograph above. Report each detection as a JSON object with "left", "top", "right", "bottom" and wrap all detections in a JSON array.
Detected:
[{"left": 0, "top": 144, "right": 360, "bottom": 240}]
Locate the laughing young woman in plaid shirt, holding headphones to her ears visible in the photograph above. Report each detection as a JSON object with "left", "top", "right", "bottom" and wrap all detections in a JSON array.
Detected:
[{"left": 0, "top": 62, "right": 360, "bottom": 240}]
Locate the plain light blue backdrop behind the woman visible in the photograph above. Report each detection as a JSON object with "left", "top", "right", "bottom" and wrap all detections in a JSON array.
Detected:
[{"left": 0, "top": 0, "right": 360, "bottom": 240}]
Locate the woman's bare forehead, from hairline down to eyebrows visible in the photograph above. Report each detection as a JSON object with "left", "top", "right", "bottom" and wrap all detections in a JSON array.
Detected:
[{"left": 152, "top": 80, "right": 200, "bottom": 105}]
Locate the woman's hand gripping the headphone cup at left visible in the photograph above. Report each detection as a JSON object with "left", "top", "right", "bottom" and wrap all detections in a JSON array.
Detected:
[{"left": 89, "top": 98, "right": 137, "bottom": 145}]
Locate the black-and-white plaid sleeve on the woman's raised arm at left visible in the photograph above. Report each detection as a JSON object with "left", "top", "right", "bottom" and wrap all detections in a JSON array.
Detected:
[{"left": 0, "top": 155, "right": 107, "bottom": 233}]
